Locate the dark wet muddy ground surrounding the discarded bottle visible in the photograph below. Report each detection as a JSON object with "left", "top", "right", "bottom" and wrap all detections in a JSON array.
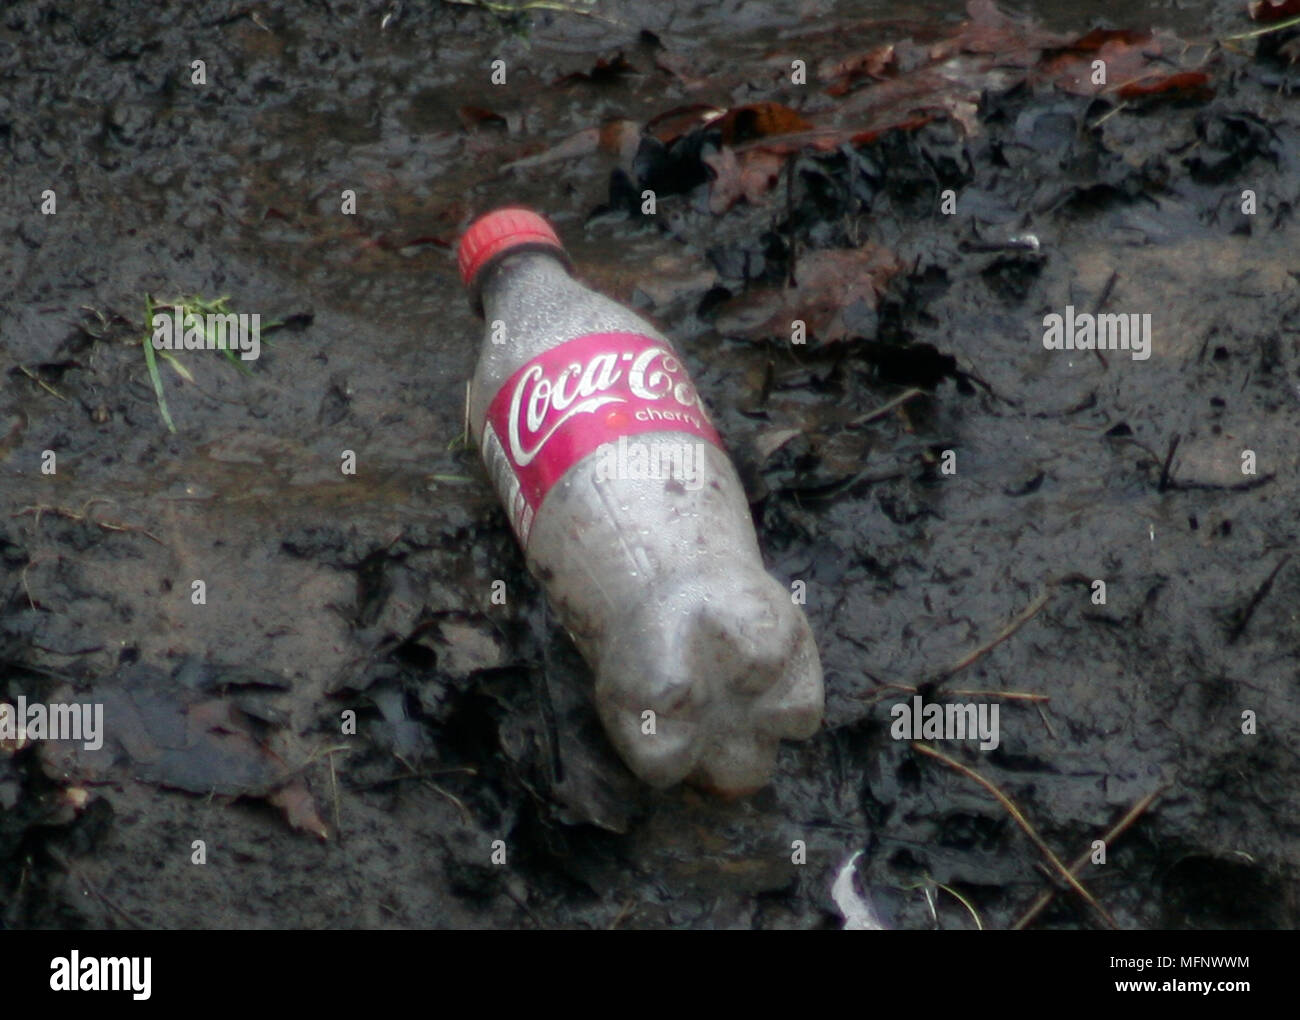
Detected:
[{"left": 0, "top": 0, "right": 1300, "bottom": 928}]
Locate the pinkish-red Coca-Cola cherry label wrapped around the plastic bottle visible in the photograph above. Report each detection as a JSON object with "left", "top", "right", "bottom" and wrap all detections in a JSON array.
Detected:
[{"left": 482, "top": 333, "right": 723, "bottom": 548}]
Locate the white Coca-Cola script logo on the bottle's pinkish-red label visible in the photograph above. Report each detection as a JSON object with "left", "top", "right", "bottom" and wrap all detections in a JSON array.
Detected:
[{"left": 507, "top": 337, "right": 709, "bottom": 466}]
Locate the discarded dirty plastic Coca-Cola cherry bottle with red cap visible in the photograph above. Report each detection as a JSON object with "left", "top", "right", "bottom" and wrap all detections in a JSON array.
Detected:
[{"left": 458, "top": 208, "right": 823, "bottom": 795}]
